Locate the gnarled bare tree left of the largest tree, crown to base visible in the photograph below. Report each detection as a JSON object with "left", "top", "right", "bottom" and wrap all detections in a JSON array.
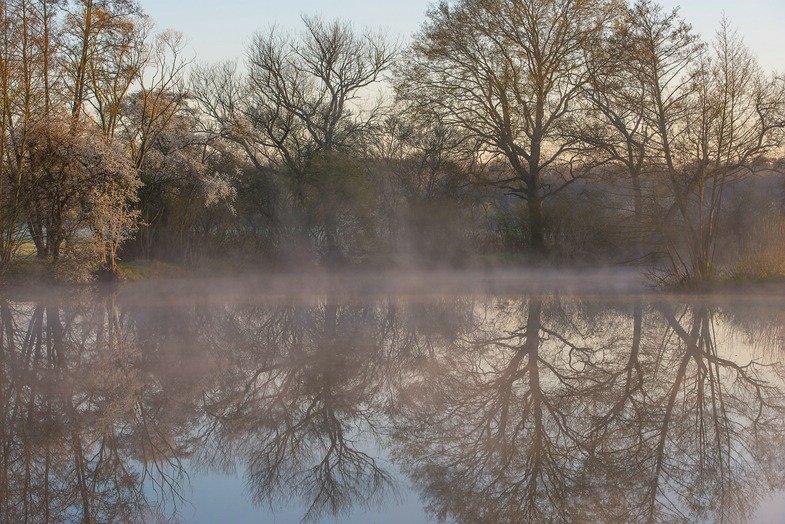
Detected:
[{"left": 193, "top": 17, "right": 396, "bottom": 261}]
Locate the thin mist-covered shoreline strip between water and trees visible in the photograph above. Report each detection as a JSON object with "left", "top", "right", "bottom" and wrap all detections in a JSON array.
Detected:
[{"left": 0, "top": 262, "right": 785, "bottom": 301}]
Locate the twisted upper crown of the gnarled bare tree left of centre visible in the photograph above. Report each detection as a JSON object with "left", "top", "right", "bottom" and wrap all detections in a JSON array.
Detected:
[{"left": 248, "top": 17, "right": 395, "bottom": 172}]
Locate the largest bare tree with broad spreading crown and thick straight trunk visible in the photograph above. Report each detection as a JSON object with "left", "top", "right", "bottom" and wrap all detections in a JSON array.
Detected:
[{"left": 398, "top": 0, "right": 614, "bottom": 251}]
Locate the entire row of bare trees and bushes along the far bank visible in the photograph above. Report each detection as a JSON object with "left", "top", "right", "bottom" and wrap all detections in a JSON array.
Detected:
[{"left": 0, "top": 0, "right": 785, "bottom": 283}]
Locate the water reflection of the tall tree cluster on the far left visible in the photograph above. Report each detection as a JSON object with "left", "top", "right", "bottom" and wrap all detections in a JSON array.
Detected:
[{"left": 0, "top": 297, "right": 194, "bottom": 522}]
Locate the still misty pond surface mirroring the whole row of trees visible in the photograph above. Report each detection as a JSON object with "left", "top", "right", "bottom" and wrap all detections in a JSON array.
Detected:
[{"left": 0, "top": 293, "right": 785, "bottom": 522}]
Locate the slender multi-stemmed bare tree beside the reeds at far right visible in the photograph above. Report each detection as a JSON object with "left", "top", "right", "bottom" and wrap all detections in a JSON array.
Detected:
[{"left": 626, "top": 0, "right": 785, "bottom": 282}]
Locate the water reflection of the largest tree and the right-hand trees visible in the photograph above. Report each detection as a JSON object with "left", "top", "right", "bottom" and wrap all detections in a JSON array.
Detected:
[{"left": 395, "top": 299, "right": 785, "bottom": 522}]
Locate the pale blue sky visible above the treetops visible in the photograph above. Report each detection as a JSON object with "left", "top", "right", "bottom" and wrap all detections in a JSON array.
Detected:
[{"left": 141, "top": 0, "right": 785, "bottom": 72}]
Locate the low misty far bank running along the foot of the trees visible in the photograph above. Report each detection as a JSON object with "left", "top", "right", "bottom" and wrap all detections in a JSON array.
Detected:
[{"left": 0, "top": 257, "right": 785, "bottom": 296}]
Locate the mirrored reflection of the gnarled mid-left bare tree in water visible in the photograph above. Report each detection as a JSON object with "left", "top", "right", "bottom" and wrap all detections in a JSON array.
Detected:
[{"left": 194, "top": 303, "right": 398, "bottom": 517}]
